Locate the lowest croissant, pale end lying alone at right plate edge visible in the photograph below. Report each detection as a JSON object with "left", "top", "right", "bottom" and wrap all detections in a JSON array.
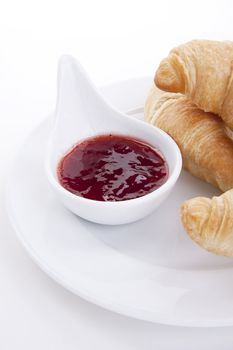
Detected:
[{"left": 180, "top": 190, "right": 233, "bottom": 256}]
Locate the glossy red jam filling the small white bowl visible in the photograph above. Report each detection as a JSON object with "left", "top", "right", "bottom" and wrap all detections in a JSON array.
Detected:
[{"left": 58, "top": 135, "right": 168, "bottom": 201}]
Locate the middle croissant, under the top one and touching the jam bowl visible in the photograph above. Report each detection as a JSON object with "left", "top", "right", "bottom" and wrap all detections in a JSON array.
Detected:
[{"left": 145, "top": 86, "right": 233, "bottom": 191}]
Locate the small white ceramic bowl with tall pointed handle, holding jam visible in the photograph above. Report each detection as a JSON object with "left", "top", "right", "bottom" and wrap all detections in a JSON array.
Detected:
[{"left": 46, "top": 56, "right": 182, "bottom": 225}]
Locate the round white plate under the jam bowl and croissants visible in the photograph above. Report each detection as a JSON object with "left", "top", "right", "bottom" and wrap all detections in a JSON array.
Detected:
[{"left": 7, "top": 79, "right": 233, "bottom": 326}]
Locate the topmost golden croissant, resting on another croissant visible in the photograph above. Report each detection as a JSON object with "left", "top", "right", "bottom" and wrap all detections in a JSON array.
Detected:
[{"left": 155, "top": 40, "right": 233, "bottom": 130}]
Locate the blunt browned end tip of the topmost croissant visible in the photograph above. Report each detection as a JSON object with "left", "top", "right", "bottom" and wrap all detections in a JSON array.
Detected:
[{"left": 154, "top": 58, "right": 184, "bottom": 92}]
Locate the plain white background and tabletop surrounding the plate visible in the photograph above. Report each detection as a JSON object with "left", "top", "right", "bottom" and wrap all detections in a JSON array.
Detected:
[{"left": 0, "top": 0, "right": 233, "bottom": 350}]
